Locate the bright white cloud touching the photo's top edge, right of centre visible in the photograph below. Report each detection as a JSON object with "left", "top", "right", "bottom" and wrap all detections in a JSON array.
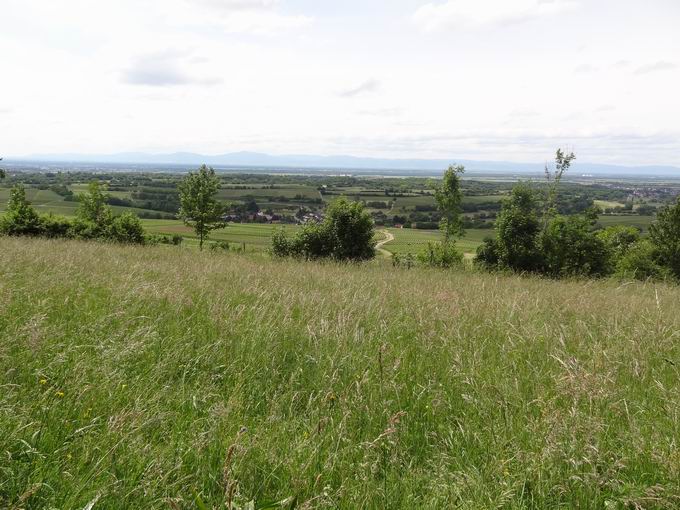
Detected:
[{"left": 413, "top": 0, "right": 579, "bottom": 32}]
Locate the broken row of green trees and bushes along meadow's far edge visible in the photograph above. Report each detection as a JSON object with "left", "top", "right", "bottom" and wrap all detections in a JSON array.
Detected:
[{"left": 0, "top": 155, "right": 680, "bottom": 279}]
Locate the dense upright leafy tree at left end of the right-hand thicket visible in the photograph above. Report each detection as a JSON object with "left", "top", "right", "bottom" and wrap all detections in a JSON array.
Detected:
[{"left": 492, "top": 184, "right": 542, "bottom": 271}]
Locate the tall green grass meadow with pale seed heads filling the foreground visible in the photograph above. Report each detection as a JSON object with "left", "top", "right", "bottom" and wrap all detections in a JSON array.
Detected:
[{"left": 0, "top": 238, "right": 680, "bottom": 510}]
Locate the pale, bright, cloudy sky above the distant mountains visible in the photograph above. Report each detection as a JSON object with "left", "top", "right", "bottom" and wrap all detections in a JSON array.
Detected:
[{"left": 0, "top": 0, "right": 680, "bottom": 165}]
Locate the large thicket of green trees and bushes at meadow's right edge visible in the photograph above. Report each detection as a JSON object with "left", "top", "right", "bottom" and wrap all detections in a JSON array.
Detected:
[{"left": 475, "top": 150, "right": 680, "bottom": 279}]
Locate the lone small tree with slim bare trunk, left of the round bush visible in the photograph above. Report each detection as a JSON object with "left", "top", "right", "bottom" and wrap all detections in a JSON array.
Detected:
[{"left": 178, "top": 165, "right": 226, "bottom": 250}]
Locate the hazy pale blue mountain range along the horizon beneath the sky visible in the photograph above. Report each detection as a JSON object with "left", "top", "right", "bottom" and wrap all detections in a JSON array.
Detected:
[{"left": 8, "top": 152, "right": 680, "bottom": 177}]
